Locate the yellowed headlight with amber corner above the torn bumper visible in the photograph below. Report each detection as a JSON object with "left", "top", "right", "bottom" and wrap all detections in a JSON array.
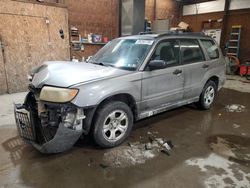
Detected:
[{"left": 40, "top": 86, "right": 78, "bottom": 103}]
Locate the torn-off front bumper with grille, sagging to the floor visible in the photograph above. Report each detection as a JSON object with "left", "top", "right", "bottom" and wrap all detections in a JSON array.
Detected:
[{"left": 14, "top": 104, "right": 83, "bottom": 153}]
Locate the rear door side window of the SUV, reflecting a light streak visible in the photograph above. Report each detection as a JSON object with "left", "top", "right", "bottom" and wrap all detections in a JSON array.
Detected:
[{"left": 180, "top": 39, "right": 205, "bottom": 64}]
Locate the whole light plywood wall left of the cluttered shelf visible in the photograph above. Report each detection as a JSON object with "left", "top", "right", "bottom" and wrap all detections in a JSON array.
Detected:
[{"left": 0, "top": 0, "right": 70, "bottom": 93}]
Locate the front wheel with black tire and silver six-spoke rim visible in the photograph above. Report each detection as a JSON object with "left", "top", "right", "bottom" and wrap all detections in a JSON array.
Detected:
[{"left": 93, "top": 101, "right": 133, "bottom": 148}]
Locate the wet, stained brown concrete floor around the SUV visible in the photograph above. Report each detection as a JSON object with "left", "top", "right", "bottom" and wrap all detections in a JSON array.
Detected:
[{"left": 0, "top": 78, "right": 250, "bottom": 188}]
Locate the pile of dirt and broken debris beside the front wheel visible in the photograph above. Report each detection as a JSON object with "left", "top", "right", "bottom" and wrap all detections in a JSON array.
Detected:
[{"left": 102, "top": 138, "right": 173, "bottom": 168}]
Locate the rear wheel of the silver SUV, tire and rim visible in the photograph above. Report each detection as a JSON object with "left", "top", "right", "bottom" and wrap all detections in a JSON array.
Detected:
[{"left": 196, "top": 80, "right": 217, "bottom": 110}]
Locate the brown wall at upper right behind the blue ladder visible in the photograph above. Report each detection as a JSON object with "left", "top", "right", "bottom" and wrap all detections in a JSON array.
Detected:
[{"left": 182, "top": 9, "right": 250, "bottom": 63}]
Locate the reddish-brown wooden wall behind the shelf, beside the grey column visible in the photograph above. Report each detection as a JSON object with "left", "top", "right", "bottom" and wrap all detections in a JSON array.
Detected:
[{"left": 64, "top": 0, "right": 119, "bottom": 58}]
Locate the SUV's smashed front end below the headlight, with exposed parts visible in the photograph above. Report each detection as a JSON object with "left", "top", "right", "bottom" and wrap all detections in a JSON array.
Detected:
[{"left": 15, "top": 91, "right": 85, "bottom": 153}]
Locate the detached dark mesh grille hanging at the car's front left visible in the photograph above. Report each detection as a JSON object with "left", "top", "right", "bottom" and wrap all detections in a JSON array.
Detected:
[{"left": 15, "top": 110, "right": 35, "bottom": 141}]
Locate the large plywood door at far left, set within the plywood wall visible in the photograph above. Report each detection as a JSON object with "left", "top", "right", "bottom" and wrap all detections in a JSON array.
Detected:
[{"left": 0, "top": 14, "right": 51, "bottom": 93}]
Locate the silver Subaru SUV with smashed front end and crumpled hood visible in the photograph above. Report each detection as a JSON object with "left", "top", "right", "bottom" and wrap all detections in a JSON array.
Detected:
[{"left": 15, "top": 33, "right": 225, "bottom": 153}]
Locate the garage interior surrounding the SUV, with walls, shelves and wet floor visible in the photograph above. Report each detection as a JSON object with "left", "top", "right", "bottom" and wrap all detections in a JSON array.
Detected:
[{"left": 0, "top": 0, "right": 250, "bottom": 188}]
